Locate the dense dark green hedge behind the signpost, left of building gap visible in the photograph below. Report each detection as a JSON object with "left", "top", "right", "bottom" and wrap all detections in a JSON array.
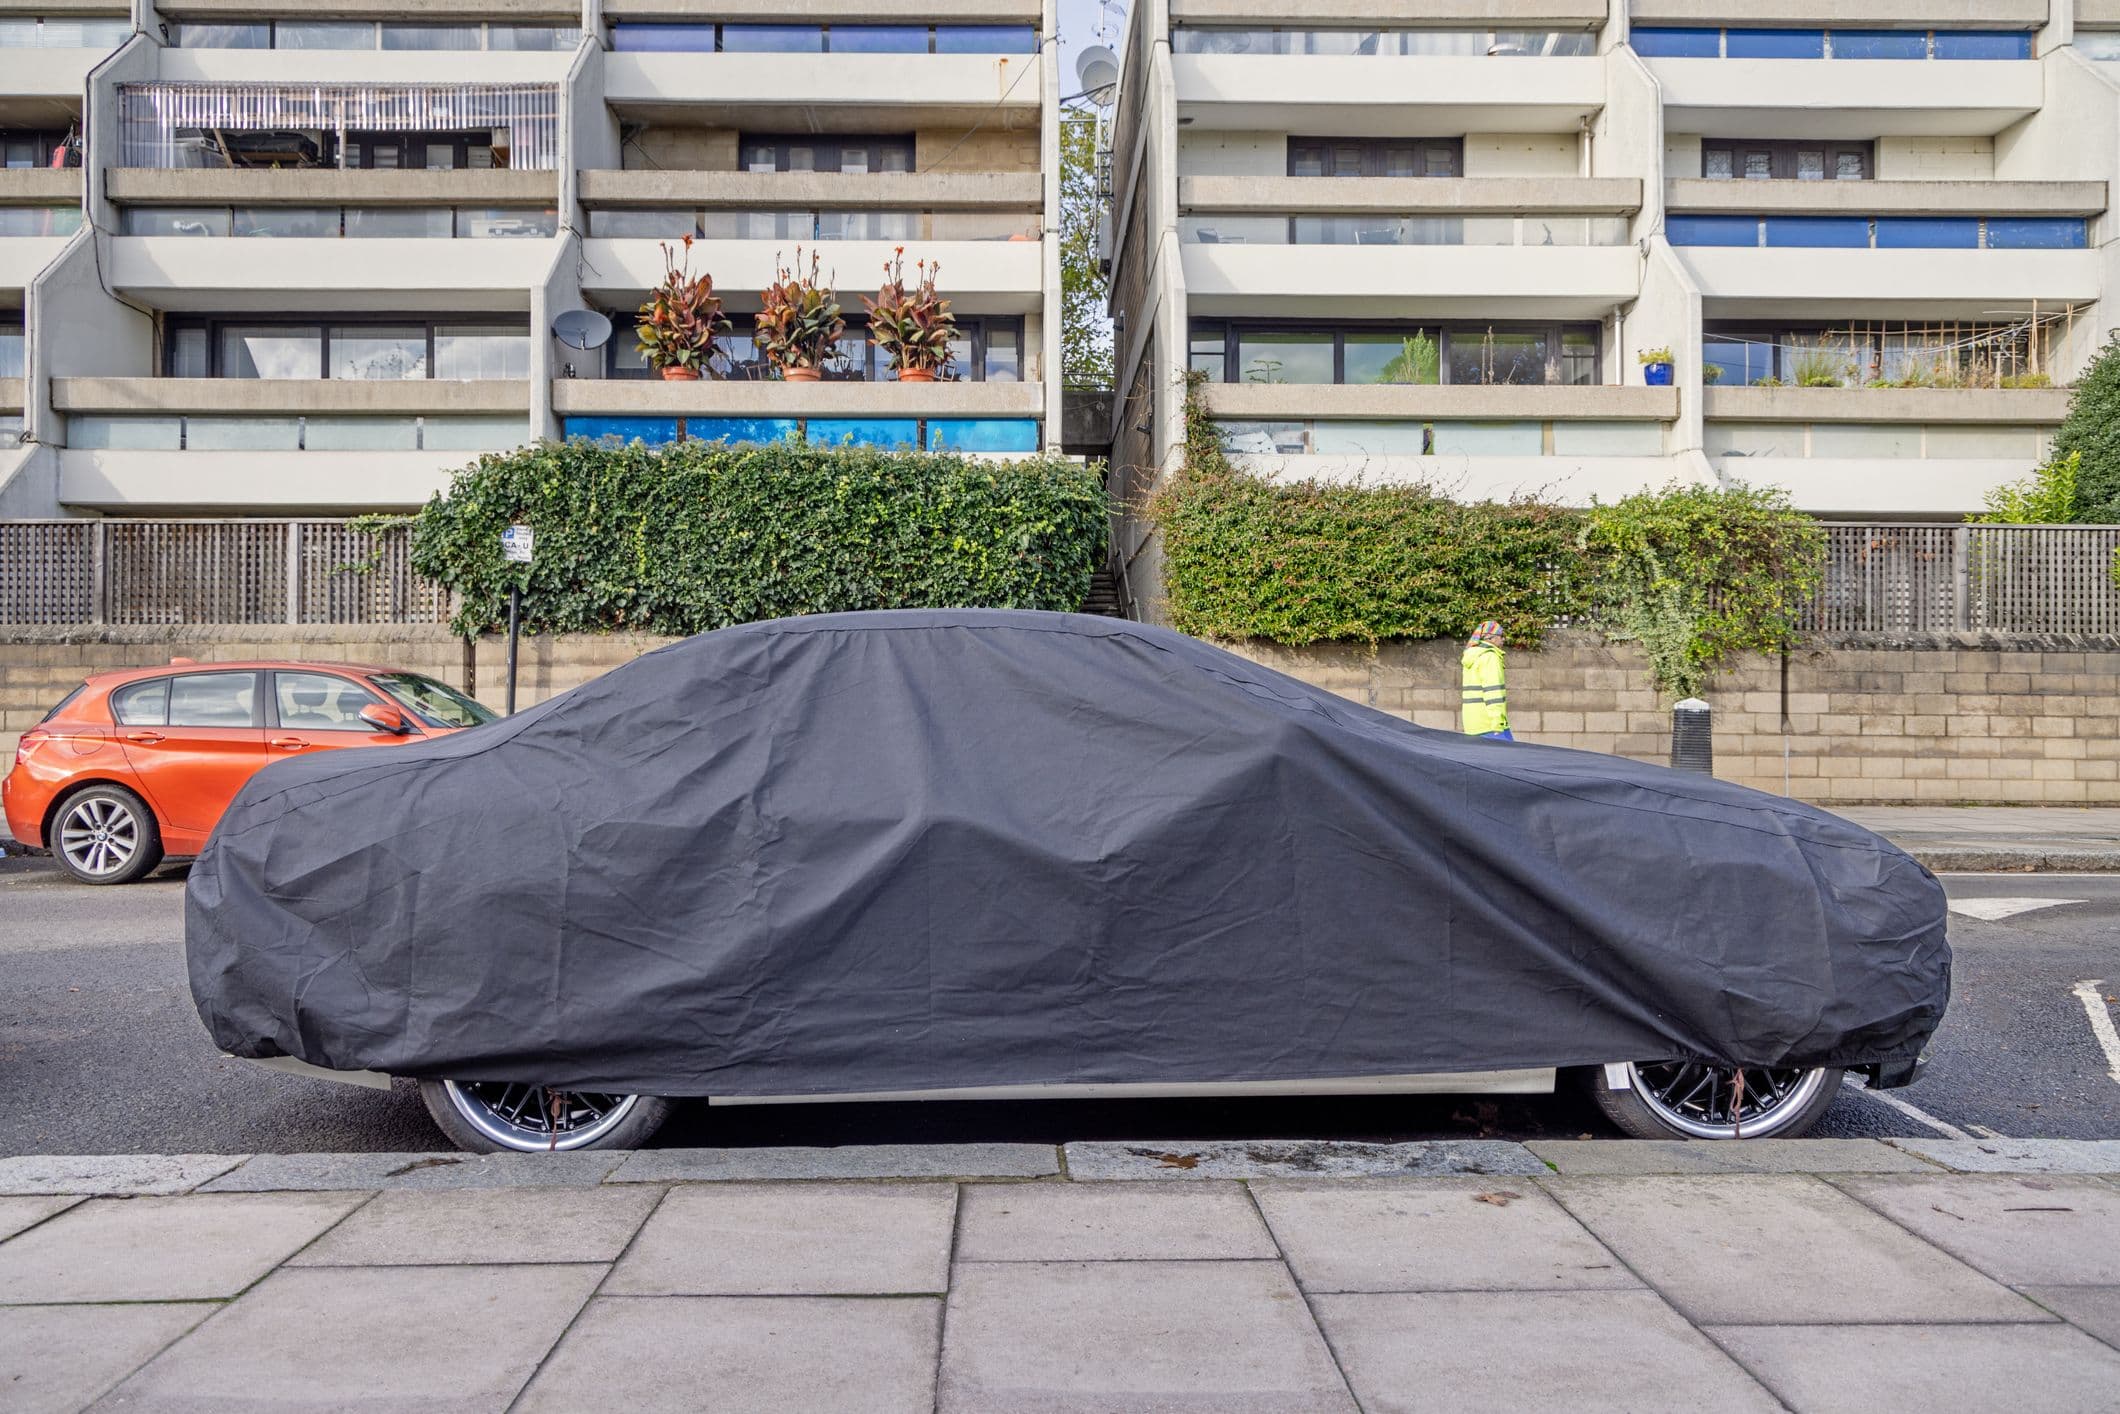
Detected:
[{"left": 411, "top": 439, "right": 1107, "bottom": 634}]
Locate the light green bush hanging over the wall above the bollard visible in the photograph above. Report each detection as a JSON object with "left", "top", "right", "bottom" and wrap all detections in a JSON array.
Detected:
[{"left": 1577, "top": 485, "right": 1825, "bottom": 695}]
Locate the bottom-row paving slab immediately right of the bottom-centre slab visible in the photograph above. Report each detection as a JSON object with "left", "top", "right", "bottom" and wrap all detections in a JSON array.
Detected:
[{"left": 1317, "top": 1289, "right": 1781, "bottom": 1414}]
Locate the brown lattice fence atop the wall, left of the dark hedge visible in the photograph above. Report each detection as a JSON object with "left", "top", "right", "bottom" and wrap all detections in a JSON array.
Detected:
[{"left": 0, "top": 519, "right": 452, "bottom": 623}]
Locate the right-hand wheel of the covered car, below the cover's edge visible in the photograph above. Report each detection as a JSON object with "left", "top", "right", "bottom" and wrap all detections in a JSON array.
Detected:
[{"left": 1590, "top": 1060, "right": 1840, "bottom": 1138}]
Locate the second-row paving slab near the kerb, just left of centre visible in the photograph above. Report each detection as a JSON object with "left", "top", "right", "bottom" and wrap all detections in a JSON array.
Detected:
[{"left": 606, "top": 1183, "right": 956, "bottom": 1295}]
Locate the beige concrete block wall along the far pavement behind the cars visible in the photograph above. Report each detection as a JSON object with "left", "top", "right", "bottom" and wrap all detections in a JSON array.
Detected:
[{"left": 0, "top": 625, "right": 2120, "bottom": 806}]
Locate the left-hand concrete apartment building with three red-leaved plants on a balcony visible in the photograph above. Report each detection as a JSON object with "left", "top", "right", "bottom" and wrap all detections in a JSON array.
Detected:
[{"left": 0, "top": 0, "right": 1060, "bottom": 519}]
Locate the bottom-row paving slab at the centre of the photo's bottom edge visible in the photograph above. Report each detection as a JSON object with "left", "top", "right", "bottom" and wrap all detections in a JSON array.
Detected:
[{"left": 937, "top": 1261, "right": 1355, "bottom": 1414}]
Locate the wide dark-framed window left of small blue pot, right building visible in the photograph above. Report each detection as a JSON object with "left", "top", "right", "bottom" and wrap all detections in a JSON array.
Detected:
[{"left": 1191, "top": 320, "right": 1603, "bottom": 386}]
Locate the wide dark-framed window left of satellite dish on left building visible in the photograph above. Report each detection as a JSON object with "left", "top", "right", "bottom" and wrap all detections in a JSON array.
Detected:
[{"left": 163, "top": 316, "right": 530, "bottom": 382}]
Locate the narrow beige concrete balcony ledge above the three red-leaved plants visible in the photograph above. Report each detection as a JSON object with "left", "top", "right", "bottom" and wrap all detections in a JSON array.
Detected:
[{"left": 580, "top": 170, "right": 1045, "bottom": 212}]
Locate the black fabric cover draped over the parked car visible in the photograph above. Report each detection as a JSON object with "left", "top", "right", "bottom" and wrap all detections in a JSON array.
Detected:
[{"left": 187, "top": 611, "right": 1948, "bottom": 1096}]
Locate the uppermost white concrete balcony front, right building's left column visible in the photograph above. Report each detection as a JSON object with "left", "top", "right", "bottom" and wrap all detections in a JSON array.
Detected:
[{"left": 1170, "top": 53, "right": 1594, "bottom": 138}]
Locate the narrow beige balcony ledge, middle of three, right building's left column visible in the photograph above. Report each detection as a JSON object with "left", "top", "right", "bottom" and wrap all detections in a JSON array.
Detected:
[{"left": 1179, "top": 176, "right": 1641, "bottom": 216}]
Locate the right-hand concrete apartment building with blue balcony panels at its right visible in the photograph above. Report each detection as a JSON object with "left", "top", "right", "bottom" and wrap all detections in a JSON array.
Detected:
[{"left": 1109, "top": 0, "right": 2120, "bottom": 602}]
